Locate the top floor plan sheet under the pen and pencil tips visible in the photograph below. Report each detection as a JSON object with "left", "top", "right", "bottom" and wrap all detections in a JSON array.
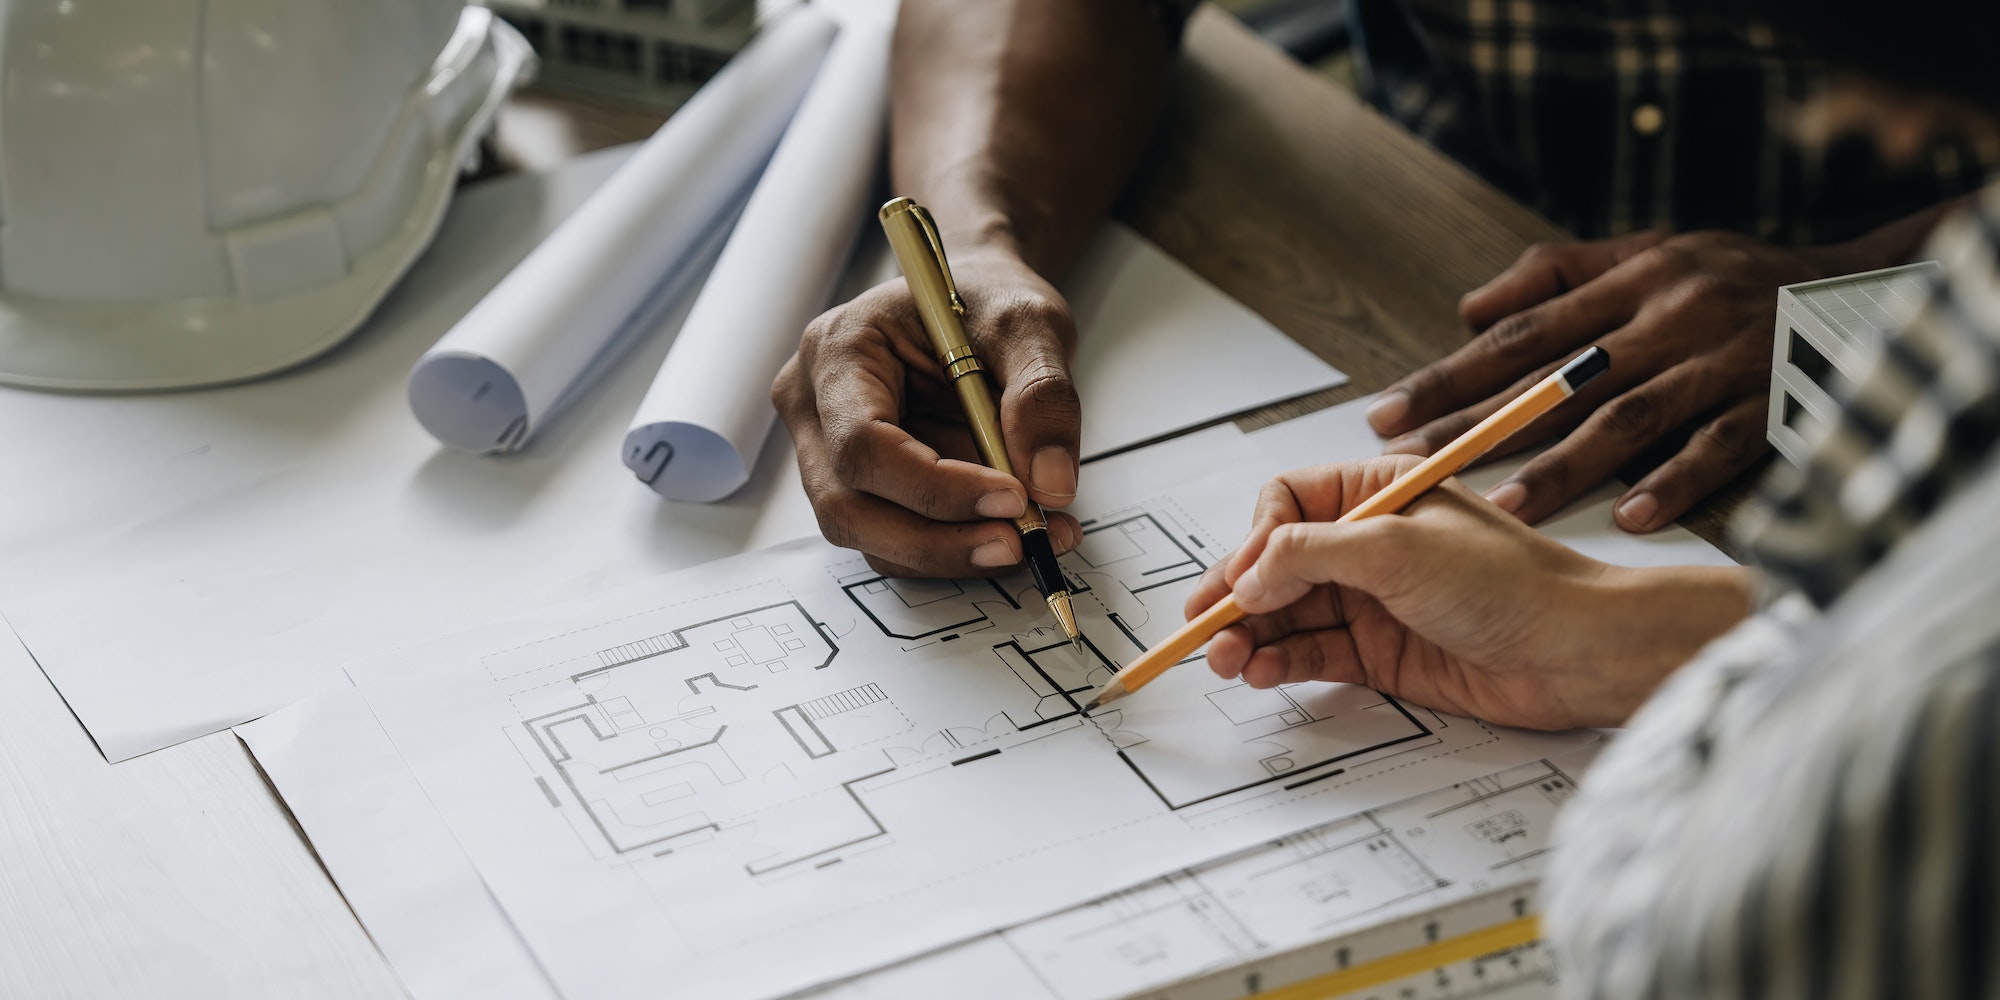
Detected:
[{"left": 358, "top": 480, "right": 1586, "bottom": 996}]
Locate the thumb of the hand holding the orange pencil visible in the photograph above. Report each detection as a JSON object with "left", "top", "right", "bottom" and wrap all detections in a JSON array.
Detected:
[{"left": 1234, "top": 514, "right": 1414, "bottom": 614}]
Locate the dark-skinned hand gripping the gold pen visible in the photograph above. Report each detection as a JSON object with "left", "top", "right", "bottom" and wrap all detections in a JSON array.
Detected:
[{"left": 770, "top": 252, "right": 1082, "bottom": 576}]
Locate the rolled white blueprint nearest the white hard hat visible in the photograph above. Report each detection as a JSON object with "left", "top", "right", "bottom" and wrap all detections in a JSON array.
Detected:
[{"left": 410, "top": 6, "right": 836, "bottom": 452}]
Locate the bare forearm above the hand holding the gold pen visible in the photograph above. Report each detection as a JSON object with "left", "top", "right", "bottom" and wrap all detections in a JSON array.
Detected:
[{"left": 890, "top": 0, "right": 1168, "bottom": 278}]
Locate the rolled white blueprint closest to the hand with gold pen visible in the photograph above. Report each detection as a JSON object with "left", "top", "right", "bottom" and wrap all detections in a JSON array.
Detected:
[{"left": 624, "top": 18, "right": 888, "bottom": 502}]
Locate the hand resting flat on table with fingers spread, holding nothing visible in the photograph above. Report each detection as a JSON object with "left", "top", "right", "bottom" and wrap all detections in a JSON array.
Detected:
[{"left": 1368, "top": 232, "right": 1826, "bottom": 532}]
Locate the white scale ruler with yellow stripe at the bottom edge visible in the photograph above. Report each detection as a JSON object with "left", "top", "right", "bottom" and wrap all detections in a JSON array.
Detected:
[{"left": 1148, "top": 886, "right": 1554, "bottom": 1000}]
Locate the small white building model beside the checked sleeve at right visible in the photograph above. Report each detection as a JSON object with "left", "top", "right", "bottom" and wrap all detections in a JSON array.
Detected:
[{"left": 1764, "top": 260, "right": 1942, "bottom": 464}]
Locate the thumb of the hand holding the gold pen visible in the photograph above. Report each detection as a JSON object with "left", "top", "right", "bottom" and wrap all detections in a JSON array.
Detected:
[{"left": 980, "top": 292, "right": 1082, "bottom": 506}]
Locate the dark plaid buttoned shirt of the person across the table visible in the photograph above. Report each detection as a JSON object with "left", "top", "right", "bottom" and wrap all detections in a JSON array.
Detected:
[{"left": 1146, "top": 0, "right": 2000, "bottom": 246}]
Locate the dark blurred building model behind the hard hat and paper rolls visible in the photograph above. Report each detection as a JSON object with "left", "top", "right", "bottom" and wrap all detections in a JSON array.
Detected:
[{"left": 482, "top": 0, "right": 786, "bottom": 108}]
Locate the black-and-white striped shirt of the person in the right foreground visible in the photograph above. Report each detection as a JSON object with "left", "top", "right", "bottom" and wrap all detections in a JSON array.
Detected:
[{"left": 1548, "top": 190, "right": 2000, "bottom": 998}]
